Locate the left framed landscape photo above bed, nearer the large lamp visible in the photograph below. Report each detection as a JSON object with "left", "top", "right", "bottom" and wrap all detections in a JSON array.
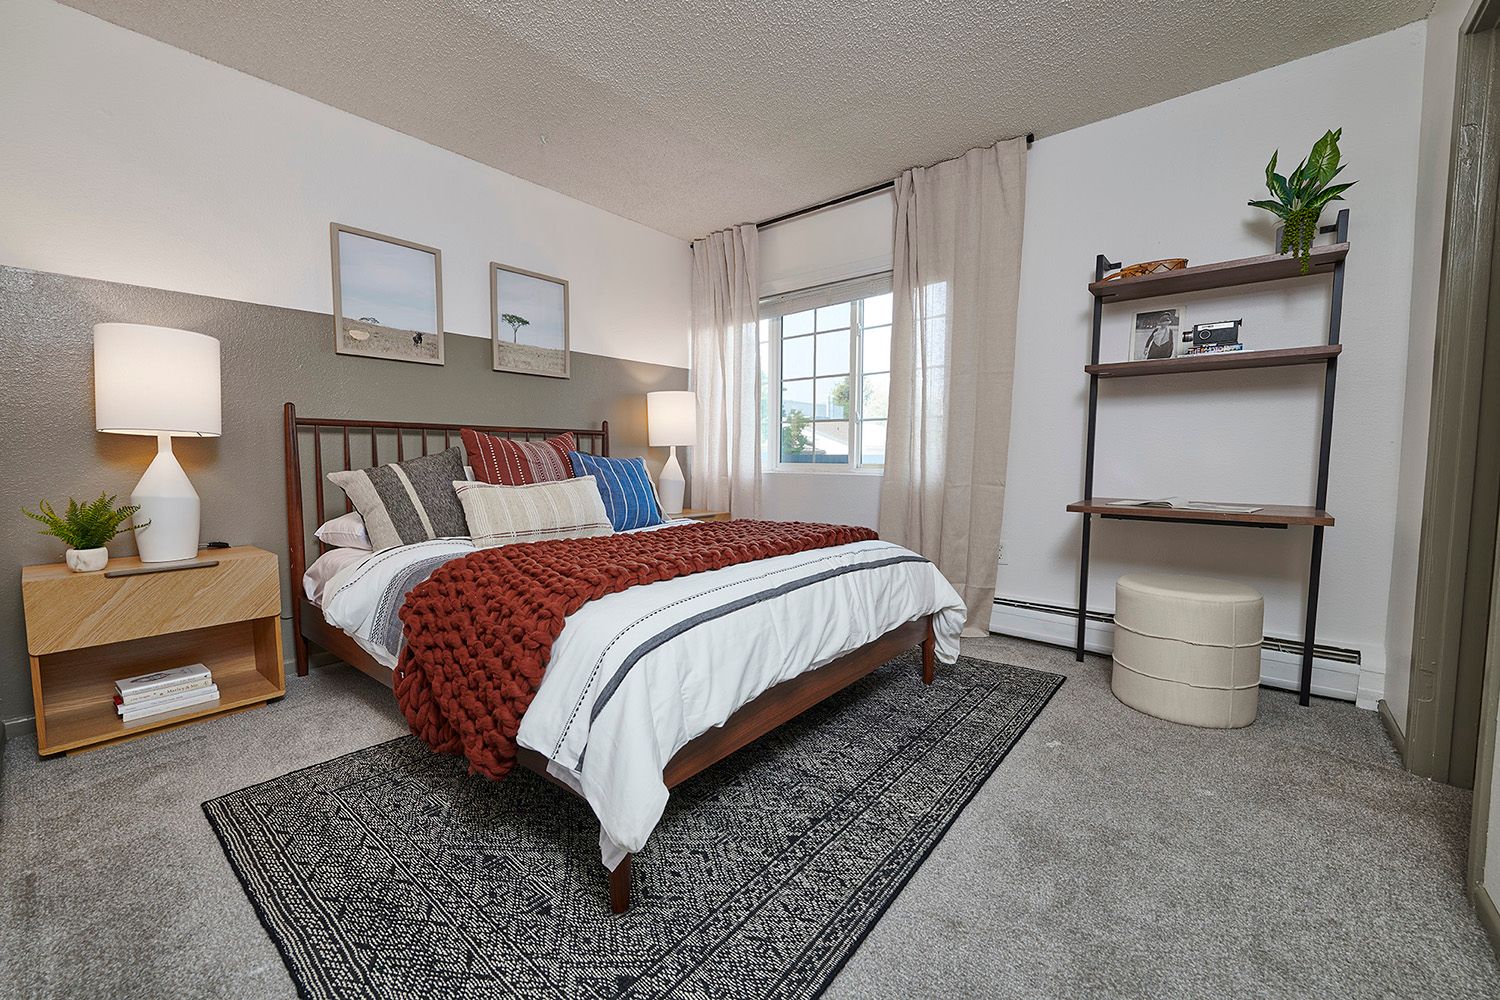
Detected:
[{"left": 329, "top": 222, "right": 443, "bottom": 364}]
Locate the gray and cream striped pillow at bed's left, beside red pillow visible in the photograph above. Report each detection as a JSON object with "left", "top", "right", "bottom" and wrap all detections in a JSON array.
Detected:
[{"left": 329, "top": 445, "right": 468, "bottom": 549}]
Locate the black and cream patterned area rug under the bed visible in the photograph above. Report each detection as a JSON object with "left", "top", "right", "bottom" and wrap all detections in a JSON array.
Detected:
[{"left": 204, "top": 654, "right": 1064, "bottom": 1000}]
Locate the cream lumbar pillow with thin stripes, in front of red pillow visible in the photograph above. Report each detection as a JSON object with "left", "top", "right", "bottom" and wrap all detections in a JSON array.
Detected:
[{"left": 453, "top": 475, "right": 615, "bottom": 549}]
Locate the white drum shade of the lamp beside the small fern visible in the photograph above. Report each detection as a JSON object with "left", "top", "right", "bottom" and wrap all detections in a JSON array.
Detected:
[{"left": 95, "top": 322, "right": 222, "bottom": 438}]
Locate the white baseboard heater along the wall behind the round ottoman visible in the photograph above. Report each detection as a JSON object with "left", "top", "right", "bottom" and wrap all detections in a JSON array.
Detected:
[{"left": 990, "top": 597, "right": 1382, "bottom": 708}]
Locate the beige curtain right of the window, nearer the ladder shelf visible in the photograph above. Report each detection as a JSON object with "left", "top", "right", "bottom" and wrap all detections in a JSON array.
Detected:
[{"left": 881, "top": 138, "right": 1026, "bottom": 636}]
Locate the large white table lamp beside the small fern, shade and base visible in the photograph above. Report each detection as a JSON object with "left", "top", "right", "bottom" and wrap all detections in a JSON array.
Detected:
[{"left": 95, "top": 322, "right": 221, "bottom": 562}]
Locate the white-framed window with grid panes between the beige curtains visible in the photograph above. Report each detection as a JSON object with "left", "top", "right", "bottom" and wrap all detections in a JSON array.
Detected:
[{"left": 761, "top": 274, "right": 891, "bottom": 471}]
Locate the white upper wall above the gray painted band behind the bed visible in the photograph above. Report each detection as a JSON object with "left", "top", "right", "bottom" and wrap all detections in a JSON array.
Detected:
[{"left": 0, "top": 0, "right": 690, "bottom": 366}]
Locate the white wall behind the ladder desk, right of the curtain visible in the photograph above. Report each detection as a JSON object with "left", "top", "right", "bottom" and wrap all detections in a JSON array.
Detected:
[{"left": 998, "top": 24, "right": 1425, "bottom": 705}]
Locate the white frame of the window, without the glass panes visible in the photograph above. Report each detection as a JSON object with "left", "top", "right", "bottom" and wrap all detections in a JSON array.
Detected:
[{"left": 758, "top": 271, "right": 891, "bottom": 475}]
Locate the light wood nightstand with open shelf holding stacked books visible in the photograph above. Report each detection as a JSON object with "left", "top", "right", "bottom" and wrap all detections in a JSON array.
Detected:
[{"left": 21, "top": 546, "right": 287, "bottom": 757}]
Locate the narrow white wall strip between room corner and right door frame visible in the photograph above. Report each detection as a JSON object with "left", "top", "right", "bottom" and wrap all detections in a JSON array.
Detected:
[{"left": 1385, "top": 0, "right": 1473, "bottom": 730}]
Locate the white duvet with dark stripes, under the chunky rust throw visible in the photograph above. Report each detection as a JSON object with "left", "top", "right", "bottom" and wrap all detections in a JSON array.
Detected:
[{"left": 323, "top": 526, "right": 965, "bottom": 868}]
